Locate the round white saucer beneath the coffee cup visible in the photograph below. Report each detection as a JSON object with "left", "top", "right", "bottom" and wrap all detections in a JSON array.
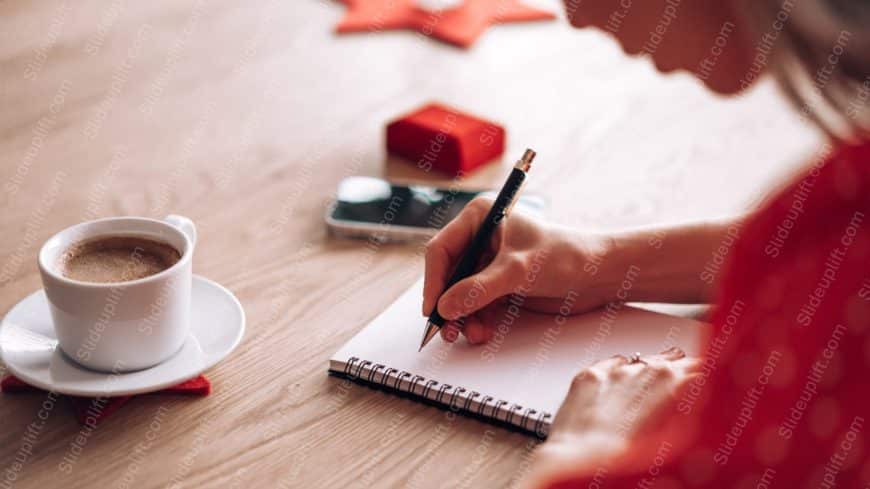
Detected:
[{"left": 0, "top": 275, "right": 245, "bottom": 397}]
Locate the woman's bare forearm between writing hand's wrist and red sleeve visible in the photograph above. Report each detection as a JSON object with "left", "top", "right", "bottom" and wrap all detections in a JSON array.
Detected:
[{"left": 585, "top": 217, "right": 742, "bottom": 303}]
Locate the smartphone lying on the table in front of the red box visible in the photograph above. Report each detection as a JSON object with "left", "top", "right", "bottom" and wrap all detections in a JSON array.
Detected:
[{"left": 326, "top": 177, "right": 545, "bottom": 241}]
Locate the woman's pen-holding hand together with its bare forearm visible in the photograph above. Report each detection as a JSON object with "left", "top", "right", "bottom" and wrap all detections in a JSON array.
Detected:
[{"left": 423, "top": 194, "right": 740, "bottom": 344}]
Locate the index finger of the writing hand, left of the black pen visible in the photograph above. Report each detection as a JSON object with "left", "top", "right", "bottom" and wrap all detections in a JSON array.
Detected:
[{"left": 423, "top": 197, "right": 492, "bottom": 315}]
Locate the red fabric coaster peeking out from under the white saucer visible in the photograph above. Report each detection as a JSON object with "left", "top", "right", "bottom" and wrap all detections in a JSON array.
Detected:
[{"left": 0, "top": 375, "right": 211, "bottom": 426}]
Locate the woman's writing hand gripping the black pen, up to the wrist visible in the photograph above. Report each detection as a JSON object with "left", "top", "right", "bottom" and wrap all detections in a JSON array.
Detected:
[{"left": 423, "top": 198, "right": 609, "bottom": 344}]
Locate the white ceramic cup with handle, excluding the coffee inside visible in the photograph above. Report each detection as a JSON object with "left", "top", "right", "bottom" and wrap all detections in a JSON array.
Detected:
[{"left": 38, "top": 215, "right": 196, "bottom": 372}]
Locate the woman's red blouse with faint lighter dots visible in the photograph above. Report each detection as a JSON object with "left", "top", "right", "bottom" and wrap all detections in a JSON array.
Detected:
[{"left": 551, "top": 142, "right": 870, "bottom": 489}]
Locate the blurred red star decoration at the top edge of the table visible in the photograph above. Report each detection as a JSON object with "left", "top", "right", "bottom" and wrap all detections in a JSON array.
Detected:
[{"left": 336, "top": 0, "right": 556, "bottom": 48}]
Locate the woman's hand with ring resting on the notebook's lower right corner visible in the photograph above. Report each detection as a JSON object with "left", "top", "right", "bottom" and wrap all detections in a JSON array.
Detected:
[{"left": 525, "top": 348, "right": 700, "bottom": 487}]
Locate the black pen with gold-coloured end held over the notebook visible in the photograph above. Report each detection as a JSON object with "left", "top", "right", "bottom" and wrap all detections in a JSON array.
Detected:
[{"left": 418, "top": 149, "right": 535, "bottom": 351}]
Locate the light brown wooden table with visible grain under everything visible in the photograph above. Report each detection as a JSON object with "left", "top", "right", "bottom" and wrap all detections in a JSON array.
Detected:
[{"left": 0, "top": 0, "right": 817, "bottom": 488}]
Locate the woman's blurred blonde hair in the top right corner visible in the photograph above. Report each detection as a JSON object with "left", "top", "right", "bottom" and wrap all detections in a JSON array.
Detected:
[{"left": 744, "top": 0, "right": 870, "bottom": 142}]
